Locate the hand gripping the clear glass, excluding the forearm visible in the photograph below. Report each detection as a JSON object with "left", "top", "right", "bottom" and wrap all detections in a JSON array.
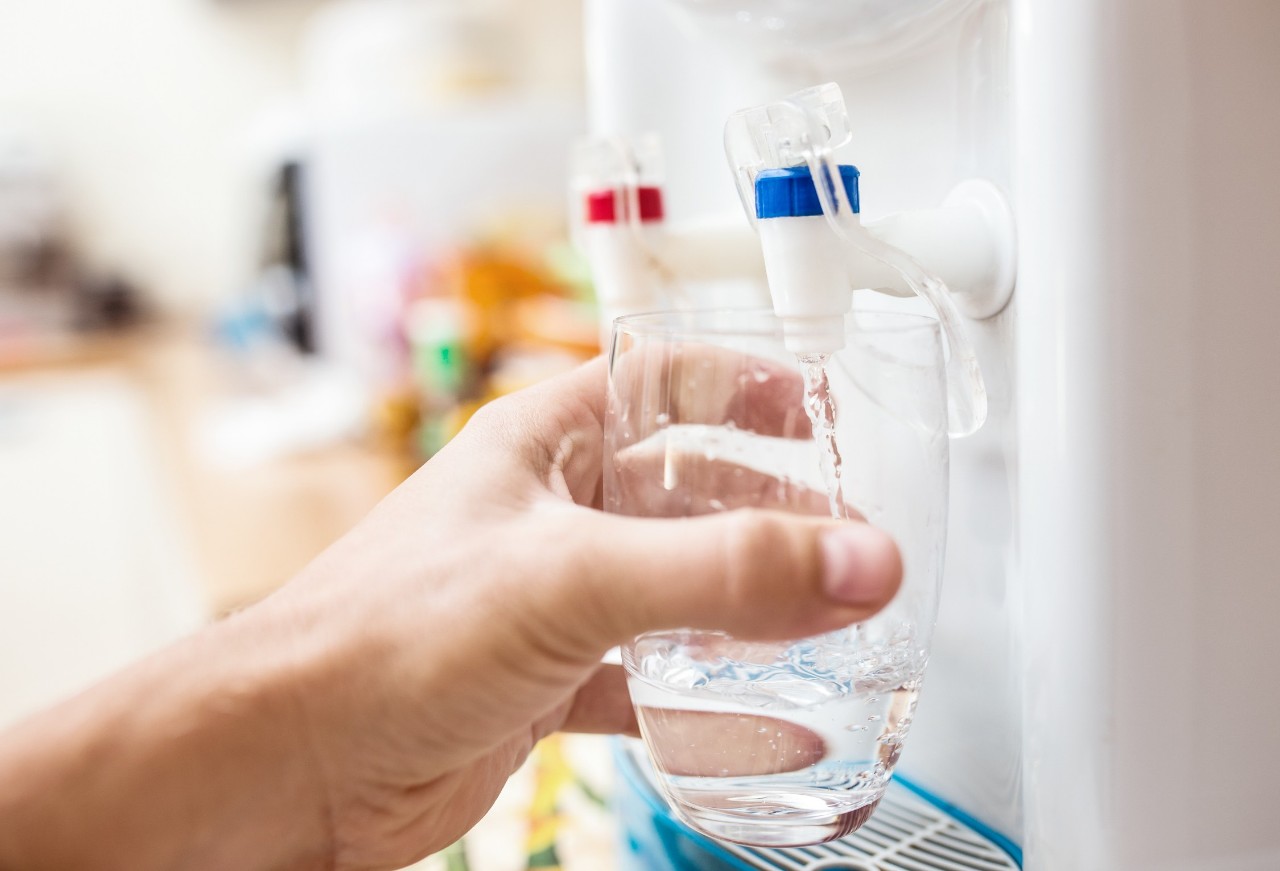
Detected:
[{"left": 273, "top": 350, "right": 901, "bottom": 867}]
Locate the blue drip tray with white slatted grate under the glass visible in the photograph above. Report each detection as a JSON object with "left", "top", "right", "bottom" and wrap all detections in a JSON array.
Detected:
[{"left": 616, "top": 740, "right": 1021, "bottom": 871}]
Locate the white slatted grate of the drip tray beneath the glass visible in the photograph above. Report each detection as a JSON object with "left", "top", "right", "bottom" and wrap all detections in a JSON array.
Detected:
[{"left": 722, "top": 783, "right": 1018, "bottom": 871}]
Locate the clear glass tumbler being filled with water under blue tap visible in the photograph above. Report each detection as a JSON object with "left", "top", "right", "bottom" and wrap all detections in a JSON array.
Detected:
[{"left": 604, "top": 311, "right": 948, "bottom": 847}]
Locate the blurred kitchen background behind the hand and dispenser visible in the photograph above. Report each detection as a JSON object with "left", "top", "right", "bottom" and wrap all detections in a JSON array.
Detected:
[{"left": 0, "top": 0, "right": 613, "bottom": 871}]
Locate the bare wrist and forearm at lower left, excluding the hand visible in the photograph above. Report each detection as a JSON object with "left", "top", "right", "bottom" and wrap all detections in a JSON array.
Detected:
[{"left": 0, "top": 604, "right": 328, "bottom": 868}]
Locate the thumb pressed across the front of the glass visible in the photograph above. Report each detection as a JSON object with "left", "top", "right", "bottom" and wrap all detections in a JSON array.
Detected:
[{"left": 540, "top": 510, "right": 902, "bottom": 649}]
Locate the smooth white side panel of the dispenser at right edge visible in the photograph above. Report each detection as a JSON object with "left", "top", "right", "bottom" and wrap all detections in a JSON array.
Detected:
[{"left": 1014, "top": 0, "right": 1280, "bottom": 871}]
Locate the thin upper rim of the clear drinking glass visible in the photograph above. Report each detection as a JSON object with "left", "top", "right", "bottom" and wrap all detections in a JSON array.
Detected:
[{"left": 612, "top": 307, "right": 941, "bottom": 338}]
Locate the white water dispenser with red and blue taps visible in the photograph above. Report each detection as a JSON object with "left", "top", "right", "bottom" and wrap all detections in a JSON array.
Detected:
[{"left": 579, "top": 0, "right": 1280, "bottom": 871}]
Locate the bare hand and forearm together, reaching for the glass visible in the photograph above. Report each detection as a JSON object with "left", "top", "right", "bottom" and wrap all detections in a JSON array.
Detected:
[{"left": 0, "top": 361, "right": 901, "bottom": 871}]
